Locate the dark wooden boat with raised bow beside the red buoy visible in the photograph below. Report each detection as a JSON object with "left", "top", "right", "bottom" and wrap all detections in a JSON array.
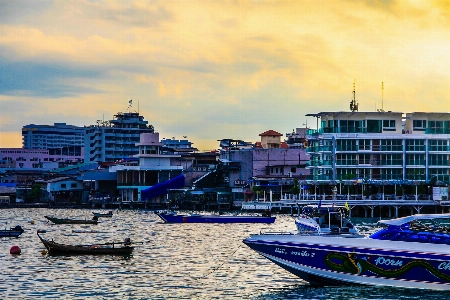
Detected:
[{"left": 37, "top": 230, "right": 134, "bottom": 255}]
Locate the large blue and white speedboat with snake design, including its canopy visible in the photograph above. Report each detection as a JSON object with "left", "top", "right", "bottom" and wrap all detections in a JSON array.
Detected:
[{"left": 243, "top": 214, "right": 450, "bottom": 290}]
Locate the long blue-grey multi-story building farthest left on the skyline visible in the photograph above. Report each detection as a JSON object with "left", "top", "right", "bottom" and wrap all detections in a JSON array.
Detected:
[{"left": 22, "top": 123, "right": 84, "bottom": 156}]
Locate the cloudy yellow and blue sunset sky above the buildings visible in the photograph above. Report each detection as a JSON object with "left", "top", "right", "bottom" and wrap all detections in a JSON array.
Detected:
[{"left": 0, "top": 0, "right": 450, "bottom": 151}]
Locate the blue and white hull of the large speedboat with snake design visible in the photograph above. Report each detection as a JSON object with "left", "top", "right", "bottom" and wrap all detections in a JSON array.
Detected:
[{"left": 244, "top": 235, "right": 450, "bottom": 290}]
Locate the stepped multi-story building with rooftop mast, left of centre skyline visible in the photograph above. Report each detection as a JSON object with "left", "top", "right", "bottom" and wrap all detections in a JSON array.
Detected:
[{"left": 84, "top": 112, "right": 154, "bottom": 162}]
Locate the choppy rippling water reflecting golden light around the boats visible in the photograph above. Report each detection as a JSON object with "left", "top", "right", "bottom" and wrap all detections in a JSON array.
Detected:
[{"left": 0, "top": 208, "right": 450, "bottom": 299}]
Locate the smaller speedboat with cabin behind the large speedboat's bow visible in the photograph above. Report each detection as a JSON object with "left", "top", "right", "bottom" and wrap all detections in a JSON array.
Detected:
[{"left": 295, "top": 205, "right": 358, "bottom": 234}]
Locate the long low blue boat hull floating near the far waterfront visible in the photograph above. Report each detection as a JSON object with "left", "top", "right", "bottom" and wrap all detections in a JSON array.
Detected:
[{"left": 156, "top": 213, "right": 276, "bottom": 224}]
